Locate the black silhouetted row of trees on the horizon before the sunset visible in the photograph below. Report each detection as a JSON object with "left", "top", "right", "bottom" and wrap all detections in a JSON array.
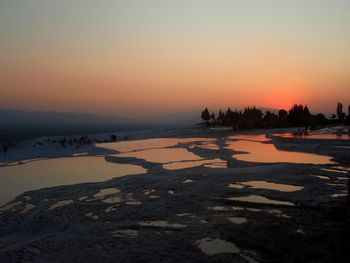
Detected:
[{"left": 201, "top": 103, "right": 350, "bottom": 130}]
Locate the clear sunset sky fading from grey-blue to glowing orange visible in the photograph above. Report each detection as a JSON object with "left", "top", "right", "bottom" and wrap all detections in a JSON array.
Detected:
[{"left": 0, "top": 0, "right": 350, "bottom": 116}]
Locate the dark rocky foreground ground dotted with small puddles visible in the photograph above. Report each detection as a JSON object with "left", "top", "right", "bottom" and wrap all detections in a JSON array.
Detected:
[{"left": 0, "top": 129, "right": 350, "bottom": 262}]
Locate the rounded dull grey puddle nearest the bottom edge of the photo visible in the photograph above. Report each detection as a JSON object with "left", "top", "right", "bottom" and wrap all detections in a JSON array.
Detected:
[{"left": 196, "top": 237, "right": 240, "bottom": 256}]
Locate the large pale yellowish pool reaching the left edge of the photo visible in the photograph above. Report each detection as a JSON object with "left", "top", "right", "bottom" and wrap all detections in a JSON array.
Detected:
[{"left": 0, "top": 157, "right": 146, "bottom": 205}]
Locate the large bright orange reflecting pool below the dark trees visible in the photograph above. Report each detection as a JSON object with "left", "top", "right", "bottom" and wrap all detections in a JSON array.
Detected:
[{"left": 226, "top": 141, "right": 334, "bottom": 164}]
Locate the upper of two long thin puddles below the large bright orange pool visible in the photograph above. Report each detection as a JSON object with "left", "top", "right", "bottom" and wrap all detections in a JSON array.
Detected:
[{"left": 228, "top": 181, "right": 304, "bottom": 192}]
